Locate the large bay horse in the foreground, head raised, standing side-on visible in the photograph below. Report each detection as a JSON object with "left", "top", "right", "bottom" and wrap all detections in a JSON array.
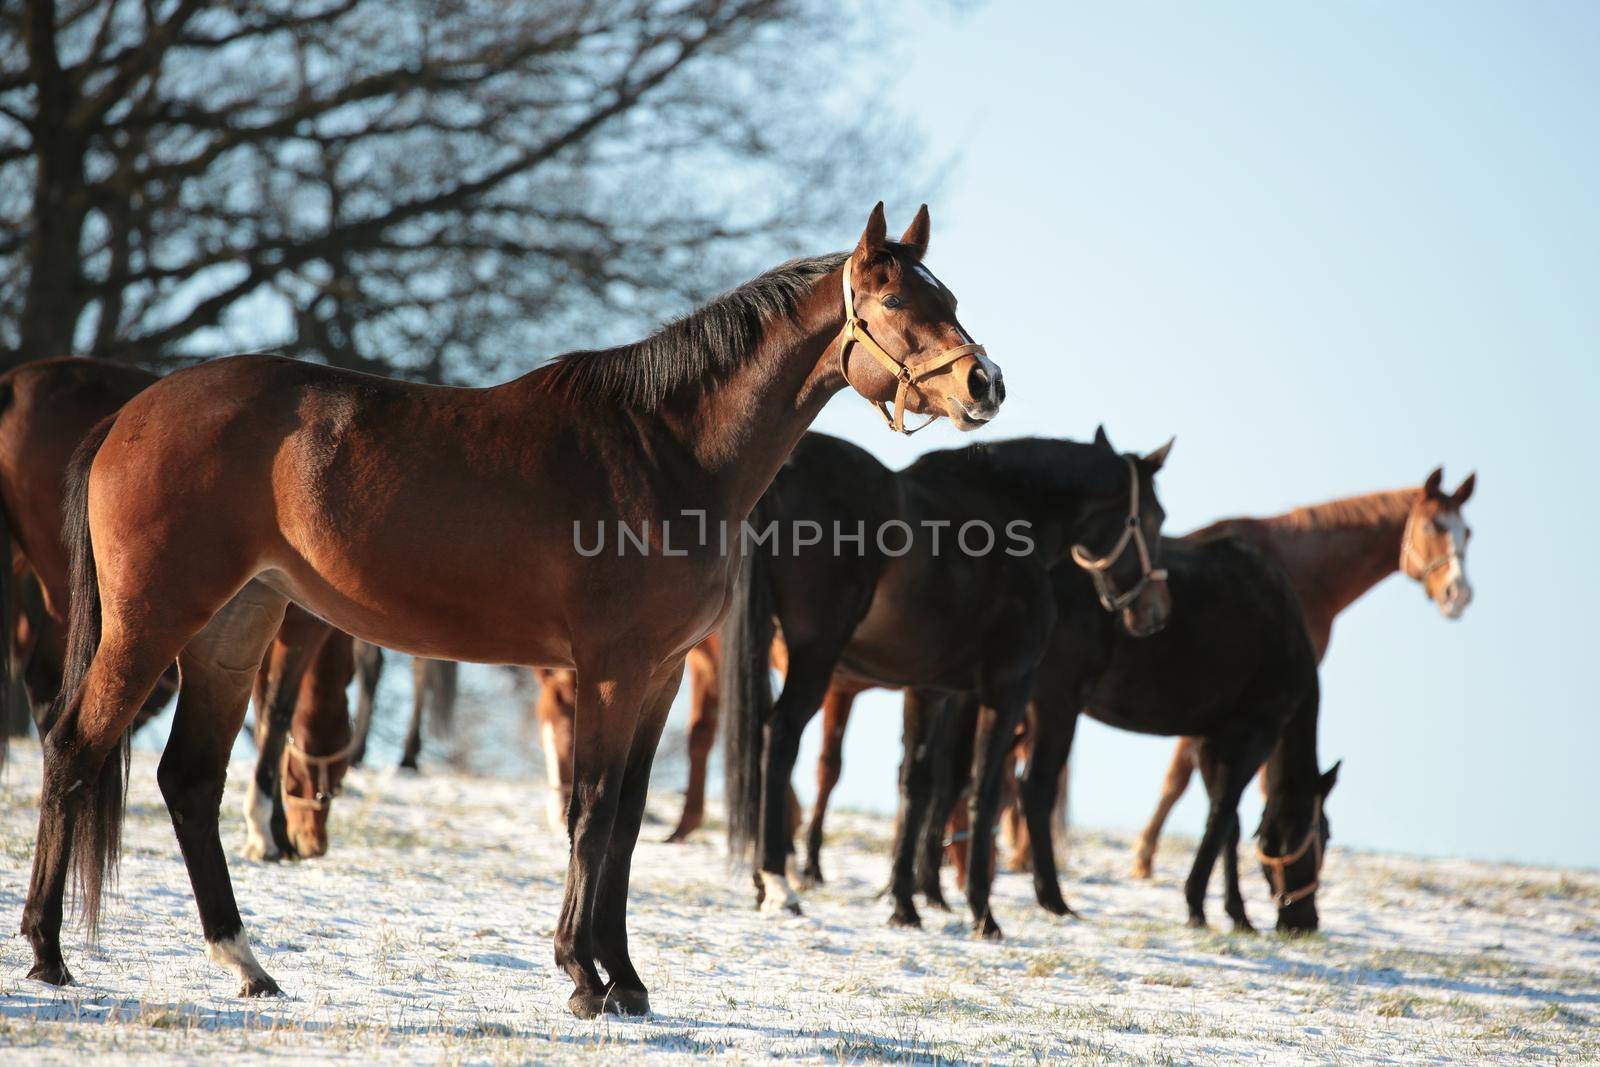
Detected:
[{"left": 22, "top": 203, "right": 1005, "bottom": 1017}]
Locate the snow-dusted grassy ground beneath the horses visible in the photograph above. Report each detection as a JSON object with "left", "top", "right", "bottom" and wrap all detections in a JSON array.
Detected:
[{"left": 0, "top": 742, "right": 1600, "bottom": 1064}]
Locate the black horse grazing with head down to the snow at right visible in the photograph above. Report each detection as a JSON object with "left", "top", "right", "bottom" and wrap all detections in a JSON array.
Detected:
[{"left": 910, "top": 537, "right": 1339, "bottom": 931}]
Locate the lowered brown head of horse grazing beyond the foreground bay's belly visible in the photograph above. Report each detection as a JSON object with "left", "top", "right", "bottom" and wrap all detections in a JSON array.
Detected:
[{"left": 278, "top": 662, "right": 355, "bottom": 859}]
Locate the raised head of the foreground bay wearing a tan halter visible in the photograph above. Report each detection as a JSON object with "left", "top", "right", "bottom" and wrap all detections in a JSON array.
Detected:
[{"left": 838, "top": 202, "right": 1005, "bottom": 434}]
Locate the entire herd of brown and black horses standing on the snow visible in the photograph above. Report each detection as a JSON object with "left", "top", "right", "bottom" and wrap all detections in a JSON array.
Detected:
[{"left": 0, "top": 205, "right": 1474, "bottom": 1017}]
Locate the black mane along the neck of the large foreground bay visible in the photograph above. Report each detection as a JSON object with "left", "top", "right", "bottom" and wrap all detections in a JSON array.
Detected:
[{"left": 541, "top": 253, "right": 850, "bottom": 411}]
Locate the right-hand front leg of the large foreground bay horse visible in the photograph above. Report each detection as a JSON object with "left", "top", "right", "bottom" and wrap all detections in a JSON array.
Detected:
[{"left": 595, "top": 667, "right": 682, "bottom": 1016}]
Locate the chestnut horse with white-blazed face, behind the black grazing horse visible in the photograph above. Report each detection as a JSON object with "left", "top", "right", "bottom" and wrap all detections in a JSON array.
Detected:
[{"left": 1133, "top": 467, "right": 1477, "bottom": 878}]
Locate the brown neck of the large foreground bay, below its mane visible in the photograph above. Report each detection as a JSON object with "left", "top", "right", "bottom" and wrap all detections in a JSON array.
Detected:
[{"left": 656, "top": 269, "right": 845, "bottom": 520}]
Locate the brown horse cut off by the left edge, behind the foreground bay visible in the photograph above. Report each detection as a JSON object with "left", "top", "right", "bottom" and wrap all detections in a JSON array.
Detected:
[{"left": 0, "top": 357, "right": 176, "bottom": 752}]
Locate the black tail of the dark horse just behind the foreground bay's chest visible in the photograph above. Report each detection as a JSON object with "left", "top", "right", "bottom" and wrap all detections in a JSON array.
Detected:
[{"left": 718, "top": 504, "right": 773, "bottom": 862}]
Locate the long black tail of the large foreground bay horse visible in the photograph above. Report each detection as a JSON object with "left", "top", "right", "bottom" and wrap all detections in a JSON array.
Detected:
[{"left": 43, "top": 419, "right": 130, "bottom": 941}]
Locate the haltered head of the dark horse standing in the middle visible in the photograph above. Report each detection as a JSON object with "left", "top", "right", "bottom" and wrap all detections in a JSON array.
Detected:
[{"left": 1072, "top": 426, "right": 1173, "bottom": 637}]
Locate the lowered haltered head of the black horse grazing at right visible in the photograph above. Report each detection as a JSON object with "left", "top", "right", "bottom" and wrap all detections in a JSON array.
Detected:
[{"left": 1256, "top": 760, "right": 1342, "bottom": 934}]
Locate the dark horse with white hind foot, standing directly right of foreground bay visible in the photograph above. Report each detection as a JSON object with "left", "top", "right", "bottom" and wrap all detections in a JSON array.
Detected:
[{"left": 720, "top": 430, "right": 1170, "bottom": 937}]
